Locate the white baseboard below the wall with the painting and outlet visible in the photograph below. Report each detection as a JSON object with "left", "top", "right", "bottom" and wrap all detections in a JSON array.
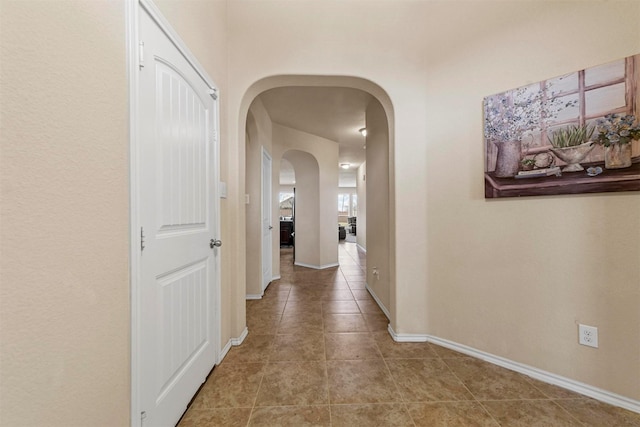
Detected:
[{"left": 389, "top": 324, "right": 640, "bottom": 413}]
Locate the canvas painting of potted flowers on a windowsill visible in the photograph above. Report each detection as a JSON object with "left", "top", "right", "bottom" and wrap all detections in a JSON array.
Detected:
[{"left": 484, "top": 55, "right": 640, "bottom": 198}]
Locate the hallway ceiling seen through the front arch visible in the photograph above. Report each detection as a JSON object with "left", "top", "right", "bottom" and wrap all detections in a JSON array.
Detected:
[{"left": 260, "top": 86, "right": 373, "bottom": 187}]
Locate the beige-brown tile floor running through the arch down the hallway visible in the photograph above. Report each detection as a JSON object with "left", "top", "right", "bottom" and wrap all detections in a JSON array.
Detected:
[{"left": 179, "top": 243, "right": 640, "bottom": 427}]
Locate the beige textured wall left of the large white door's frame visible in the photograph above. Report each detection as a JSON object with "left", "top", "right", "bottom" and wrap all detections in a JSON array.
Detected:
[{"left": 0, "top": 1, "right": 130, "bottom": 426}]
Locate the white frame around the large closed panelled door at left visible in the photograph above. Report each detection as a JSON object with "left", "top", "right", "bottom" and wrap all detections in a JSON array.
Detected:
[{"left": 125, "top": 0, "right": 221, "bottom": 427}]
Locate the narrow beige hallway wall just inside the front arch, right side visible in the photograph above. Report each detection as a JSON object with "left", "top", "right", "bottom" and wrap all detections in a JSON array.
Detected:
[{"left": 365, "top": 100, "right": 391, "bottom": 313}]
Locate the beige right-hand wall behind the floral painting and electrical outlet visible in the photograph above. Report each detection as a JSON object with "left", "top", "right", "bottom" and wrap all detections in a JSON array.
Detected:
[{"left": 420, "top": 2, "right": 640, "bottom": 400}]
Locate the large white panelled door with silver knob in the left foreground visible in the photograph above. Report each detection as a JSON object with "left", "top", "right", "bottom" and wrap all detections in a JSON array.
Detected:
[{"left": 137, "top": 7, "right": 219, "bottom": 427}]
